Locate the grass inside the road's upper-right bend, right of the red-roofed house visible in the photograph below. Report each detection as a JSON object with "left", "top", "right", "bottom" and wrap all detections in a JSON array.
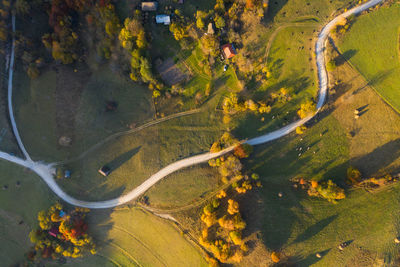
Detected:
[{"left": 236, "top": 24, "right": 318, "bottom": 138}]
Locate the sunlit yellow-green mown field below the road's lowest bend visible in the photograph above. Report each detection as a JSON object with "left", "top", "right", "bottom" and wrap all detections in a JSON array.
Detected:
[{"left": 89, "top": 208, "right": 207, "bottom": 266}]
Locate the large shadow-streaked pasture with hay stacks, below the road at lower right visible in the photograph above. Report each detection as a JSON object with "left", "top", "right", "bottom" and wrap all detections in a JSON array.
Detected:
[{"left": 244, "top": 44, "right": 400, "bottom": 266}]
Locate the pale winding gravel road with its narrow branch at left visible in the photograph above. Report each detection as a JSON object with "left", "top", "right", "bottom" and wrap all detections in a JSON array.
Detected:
[{"left": 0, "top": 0, "right": 384, "bottom": 209}]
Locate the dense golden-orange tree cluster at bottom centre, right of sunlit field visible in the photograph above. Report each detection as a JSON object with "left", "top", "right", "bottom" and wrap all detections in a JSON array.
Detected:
[{"left": 199, "top": 191, "right": 248, "bottom": 266}]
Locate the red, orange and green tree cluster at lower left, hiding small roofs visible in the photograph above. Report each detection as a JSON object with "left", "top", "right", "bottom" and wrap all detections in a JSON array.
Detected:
[{"left": 29, "top": 203, "right": 96, "bottom": 260}]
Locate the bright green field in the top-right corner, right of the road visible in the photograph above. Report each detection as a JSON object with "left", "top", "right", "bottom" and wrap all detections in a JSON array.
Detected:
[{"left": 339, "top": 3, "right": 400, "bottom": 111}]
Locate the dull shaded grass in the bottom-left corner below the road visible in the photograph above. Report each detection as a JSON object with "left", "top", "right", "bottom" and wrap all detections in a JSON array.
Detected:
[{"left": 0, "top": 161, "right": 55, "bottom": 266}]
